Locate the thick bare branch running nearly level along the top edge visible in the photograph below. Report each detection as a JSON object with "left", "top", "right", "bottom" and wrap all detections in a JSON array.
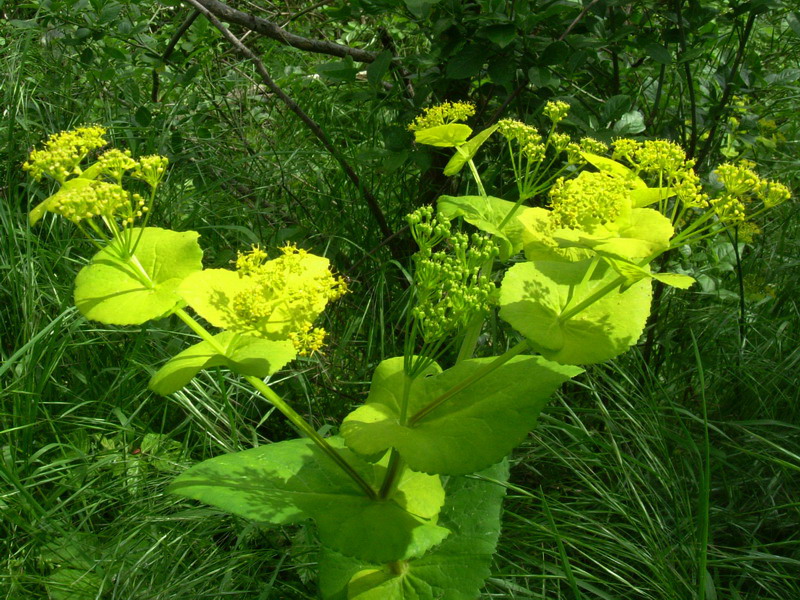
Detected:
[{"left": 184, "top": 0, "right": 377, "bottom": 63}]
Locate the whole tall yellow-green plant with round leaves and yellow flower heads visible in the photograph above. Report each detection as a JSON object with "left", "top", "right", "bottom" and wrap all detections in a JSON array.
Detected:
[{"left": 24, "top": 109, "right": 789, "bottom": 600}]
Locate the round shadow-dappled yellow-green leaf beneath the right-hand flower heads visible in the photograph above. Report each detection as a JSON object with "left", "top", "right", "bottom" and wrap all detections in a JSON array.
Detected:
[{"left": 500, "top": 259, "right": 652, "bottom": 365}]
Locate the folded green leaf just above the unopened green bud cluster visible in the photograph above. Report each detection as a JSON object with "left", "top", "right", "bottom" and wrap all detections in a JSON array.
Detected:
[{"left": 436, "top": 196, "right": 530, "bottom": 260}]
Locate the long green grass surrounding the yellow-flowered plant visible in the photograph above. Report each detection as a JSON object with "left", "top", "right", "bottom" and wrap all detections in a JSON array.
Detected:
[{"left": 0, "top": 7, "right": 800, "bottom": 600}]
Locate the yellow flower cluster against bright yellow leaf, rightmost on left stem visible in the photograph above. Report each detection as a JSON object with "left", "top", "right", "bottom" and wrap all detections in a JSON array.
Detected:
[{"left": 232, "top": 245, "right": 347, "bottom": 355}]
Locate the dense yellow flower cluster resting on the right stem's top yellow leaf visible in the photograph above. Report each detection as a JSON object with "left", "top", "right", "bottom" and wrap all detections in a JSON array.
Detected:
[{"left": 550, "top": 171, "right": 630, "bottom": 231}]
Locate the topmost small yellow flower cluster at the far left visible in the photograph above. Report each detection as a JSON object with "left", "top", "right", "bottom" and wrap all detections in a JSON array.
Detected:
[{"left": 22, "top": 126, "right": 107, "bottom": 183}]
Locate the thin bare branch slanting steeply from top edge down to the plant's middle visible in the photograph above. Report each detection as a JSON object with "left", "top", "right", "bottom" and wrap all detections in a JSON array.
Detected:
[{"left": 184, "top": 0, "right": 402, "bottom": 258}]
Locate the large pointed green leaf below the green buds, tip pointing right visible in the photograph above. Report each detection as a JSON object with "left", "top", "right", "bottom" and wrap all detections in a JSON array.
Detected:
[{"left": 341, "top": 356, "right": 581, "bottom": 475}]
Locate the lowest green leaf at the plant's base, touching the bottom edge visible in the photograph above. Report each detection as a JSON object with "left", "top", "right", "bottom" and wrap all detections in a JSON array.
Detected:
[{"left": 319, "top": 461, "right": 508, "bottom": 600}]
